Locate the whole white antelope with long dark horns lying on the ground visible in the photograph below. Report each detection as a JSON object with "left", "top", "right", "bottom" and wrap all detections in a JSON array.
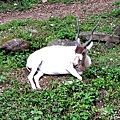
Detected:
[{"left": 26, "top": 17, "right": 100, "bottom": 89}]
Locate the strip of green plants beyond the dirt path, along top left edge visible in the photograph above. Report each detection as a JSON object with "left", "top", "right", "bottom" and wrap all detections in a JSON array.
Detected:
[{"left": 0, "top": 0, "right": 85, "bottom": 12}]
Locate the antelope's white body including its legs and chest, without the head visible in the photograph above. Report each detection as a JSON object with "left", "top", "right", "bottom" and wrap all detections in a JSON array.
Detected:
[{"left": 26, "top": 46, "right": 91, "bottom": 89}]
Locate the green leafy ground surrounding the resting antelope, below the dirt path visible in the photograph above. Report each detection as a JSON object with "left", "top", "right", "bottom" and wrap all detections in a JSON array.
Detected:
[{"left": 0, "top": 0, "right": 120, "bottom": 120}]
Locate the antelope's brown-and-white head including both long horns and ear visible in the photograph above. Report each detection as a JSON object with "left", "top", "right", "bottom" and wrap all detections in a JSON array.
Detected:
[{"left": 73, "top": 18, "right": 100, "bottom": 74}]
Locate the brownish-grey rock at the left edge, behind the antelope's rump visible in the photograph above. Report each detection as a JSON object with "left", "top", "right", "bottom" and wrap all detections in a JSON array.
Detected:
[{"left": 0, "top": 38, "right": 30, "bottom": 51}]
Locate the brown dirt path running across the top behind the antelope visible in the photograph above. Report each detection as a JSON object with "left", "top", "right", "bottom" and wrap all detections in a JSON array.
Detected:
[{"left": 0, "top": 0, "right": 115, "bottom": 24}]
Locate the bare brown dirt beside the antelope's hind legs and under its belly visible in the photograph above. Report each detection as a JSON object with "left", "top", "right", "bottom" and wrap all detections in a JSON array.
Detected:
[{"left": 0, "top": 68, "right": 72, "bottom": 93}]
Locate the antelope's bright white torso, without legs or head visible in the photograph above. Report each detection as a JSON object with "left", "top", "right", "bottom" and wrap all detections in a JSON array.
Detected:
[{"left": 26, "top": 46, "right": 75, "bottom": 74}]
